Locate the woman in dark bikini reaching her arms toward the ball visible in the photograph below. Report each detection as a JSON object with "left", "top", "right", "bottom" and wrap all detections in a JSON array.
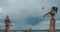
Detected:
[{"left": 43, "top": 7, "right": 57, "bottom": 32}]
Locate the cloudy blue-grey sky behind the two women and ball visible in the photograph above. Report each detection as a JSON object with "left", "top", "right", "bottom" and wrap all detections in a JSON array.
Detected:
[{"left": 0, "top": 0, "right": 60, "bottom": 30}]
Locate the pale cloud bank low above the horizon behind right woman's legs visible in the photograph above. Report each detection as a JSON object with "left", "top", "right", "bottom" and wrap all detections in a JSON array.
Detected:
[{"left": 32, "top": 20, "right": 60, "bottom": 30}]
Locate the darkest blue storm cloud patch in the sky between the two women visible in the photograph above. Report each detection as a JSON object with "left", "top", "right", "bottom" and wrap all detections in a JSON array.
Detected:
[{"left": 26, "top": 16, "right": 44, "bottom": 25}]
